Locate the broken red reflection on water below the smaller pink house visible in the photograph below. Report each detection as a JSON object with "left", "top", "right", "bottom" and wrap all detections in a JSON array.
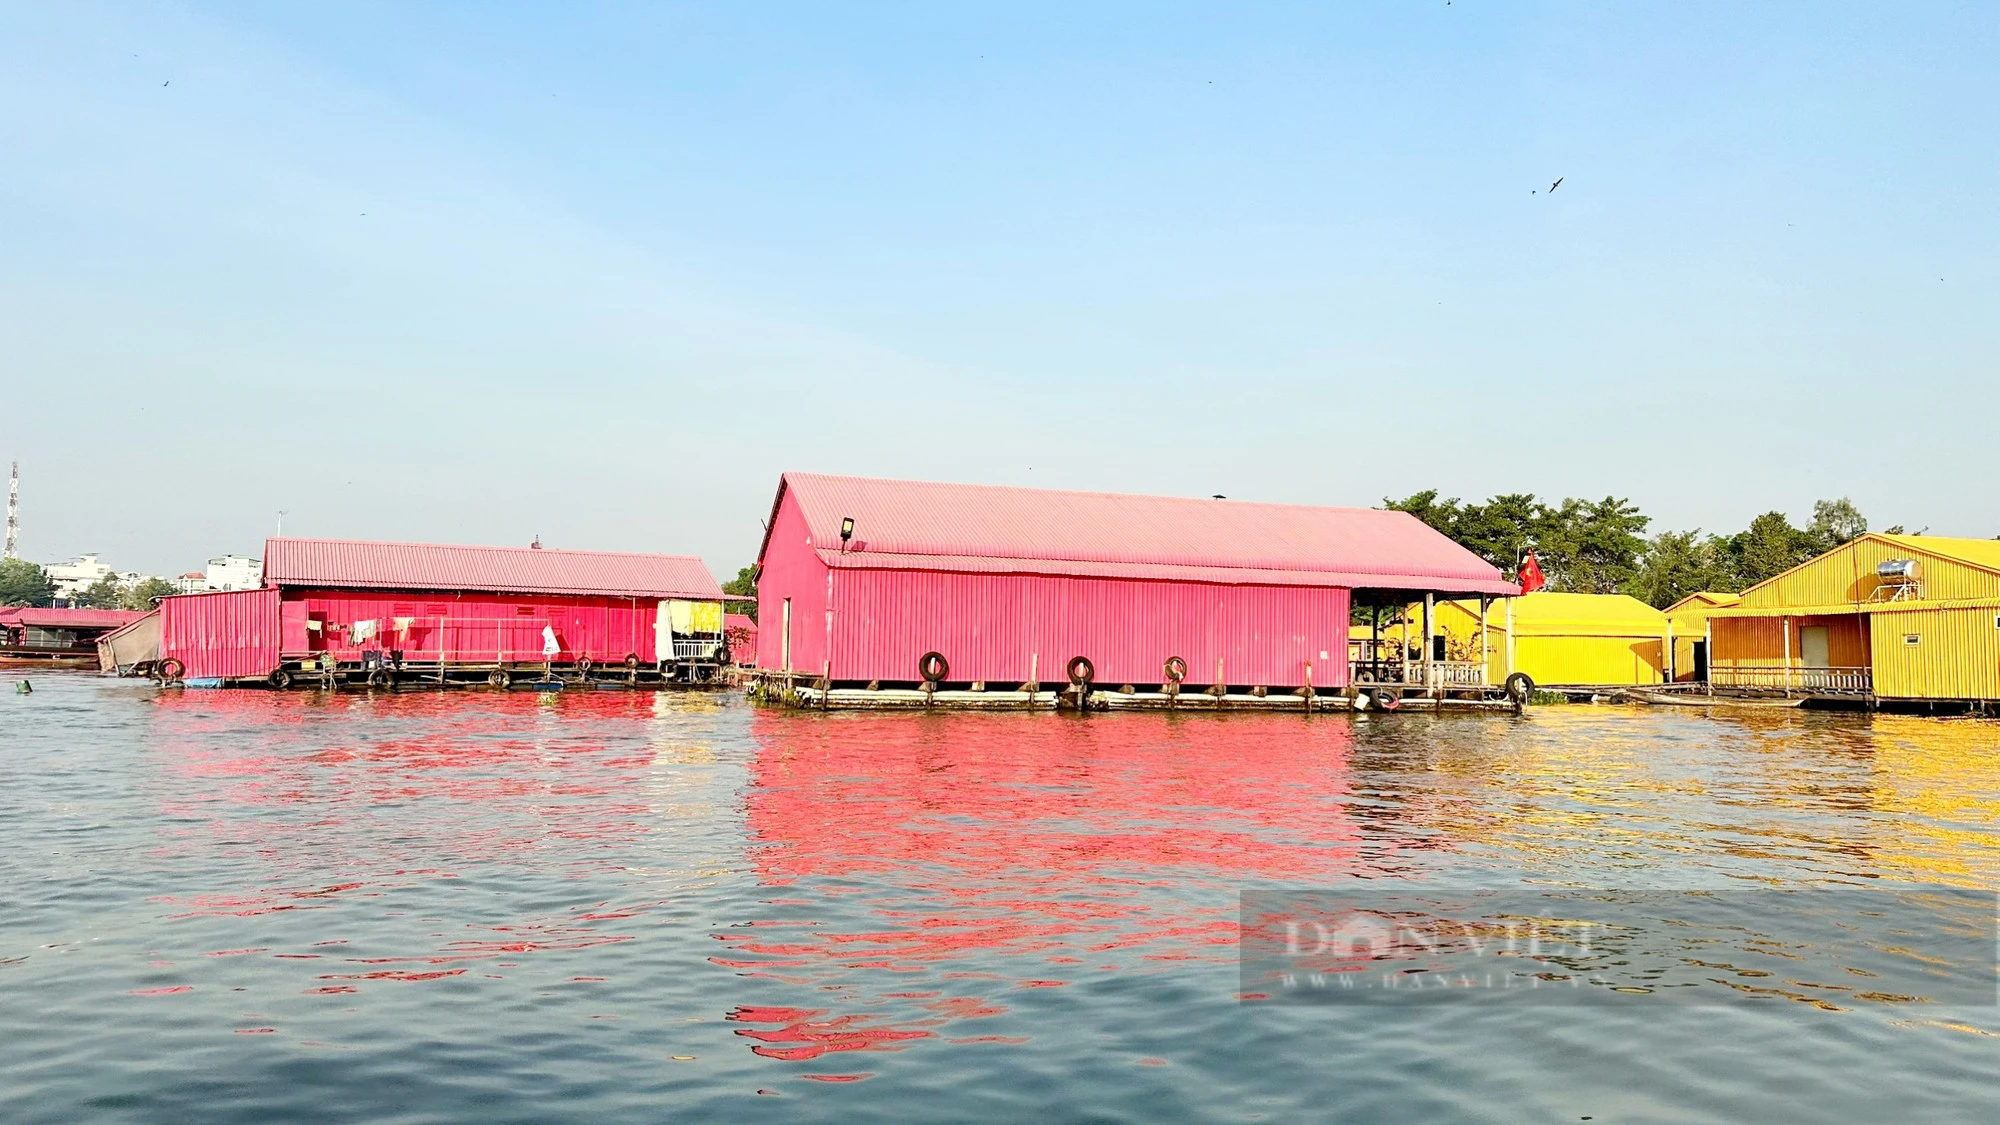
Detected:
[{"left": 139, "top": 691, "right": 680, "bottom": 991}]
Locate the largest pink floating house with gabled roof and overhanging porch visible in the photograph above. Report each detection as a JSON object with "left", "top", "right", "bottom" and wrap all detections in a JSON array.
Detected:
[{"left": 758, "top": 472, "right": 1520, "bottom": 691}]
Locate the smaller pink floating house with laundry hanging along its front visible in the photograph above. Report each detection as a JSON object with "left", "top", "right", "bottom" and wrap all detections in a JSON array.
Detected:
[{"left": 160, "top": 538, "right": 722, "bottom": 687}]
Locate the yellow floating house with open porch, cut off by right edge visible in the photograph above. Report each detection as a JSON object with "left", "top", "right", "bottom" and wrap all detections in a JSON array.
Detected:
[{"left": 1708, "top": 534, "right": 2000, "bottom": 709}]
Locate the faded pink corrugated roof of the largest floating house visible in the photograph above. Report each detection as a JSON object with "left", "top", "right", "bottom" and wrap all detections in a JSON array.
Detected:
[{"left": 774, "top": 472, "right": 1518, "bottom": 595}]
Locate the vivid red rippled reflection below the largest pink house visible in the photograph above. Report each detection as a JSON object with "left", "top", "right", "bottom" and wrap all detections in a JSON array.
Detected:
[{"left": 732, "top": 711, "right": 1404, "bottom": 1059}]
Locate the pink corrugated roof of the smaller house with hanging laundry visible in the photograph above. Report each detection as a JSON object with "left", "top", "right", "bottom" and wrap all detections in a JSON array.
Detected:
[{"left": 264, "top": 538, "right": 722, "bottom": 601}]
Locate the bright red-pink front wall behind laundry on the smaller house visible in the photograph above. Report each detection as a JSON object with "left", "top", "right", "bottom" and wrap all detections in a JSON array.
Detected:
[{"left": 284, "top": 589, "right": 660, "bottom": 665}]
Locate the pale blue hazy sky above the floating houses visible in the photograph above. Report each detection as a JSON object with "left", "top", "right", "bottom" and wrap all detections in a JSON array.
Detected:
[{"left": 0, "top": 0, "right": 2000, "bottom": 577}]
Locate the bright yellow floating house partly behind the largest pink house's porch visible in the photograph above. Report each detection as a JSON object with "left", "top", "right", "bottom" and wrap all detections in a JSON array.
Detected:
[{"left": 1384, "top": 591, "right": 1668, "bottom": 687}]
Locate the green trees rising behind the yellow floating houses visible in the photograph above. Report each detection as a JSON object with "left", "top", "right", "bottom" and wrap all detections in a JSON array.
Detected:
[{"left": 1382, "top": 488, "right": 1902, "bottom": 609}]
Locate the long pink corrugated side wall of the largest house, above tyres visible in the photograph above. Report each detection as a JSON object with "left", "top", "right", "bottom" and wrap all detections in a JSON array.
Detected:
[{"left": 814, "top": 571, "right": 1348, "bottom": 689}]
